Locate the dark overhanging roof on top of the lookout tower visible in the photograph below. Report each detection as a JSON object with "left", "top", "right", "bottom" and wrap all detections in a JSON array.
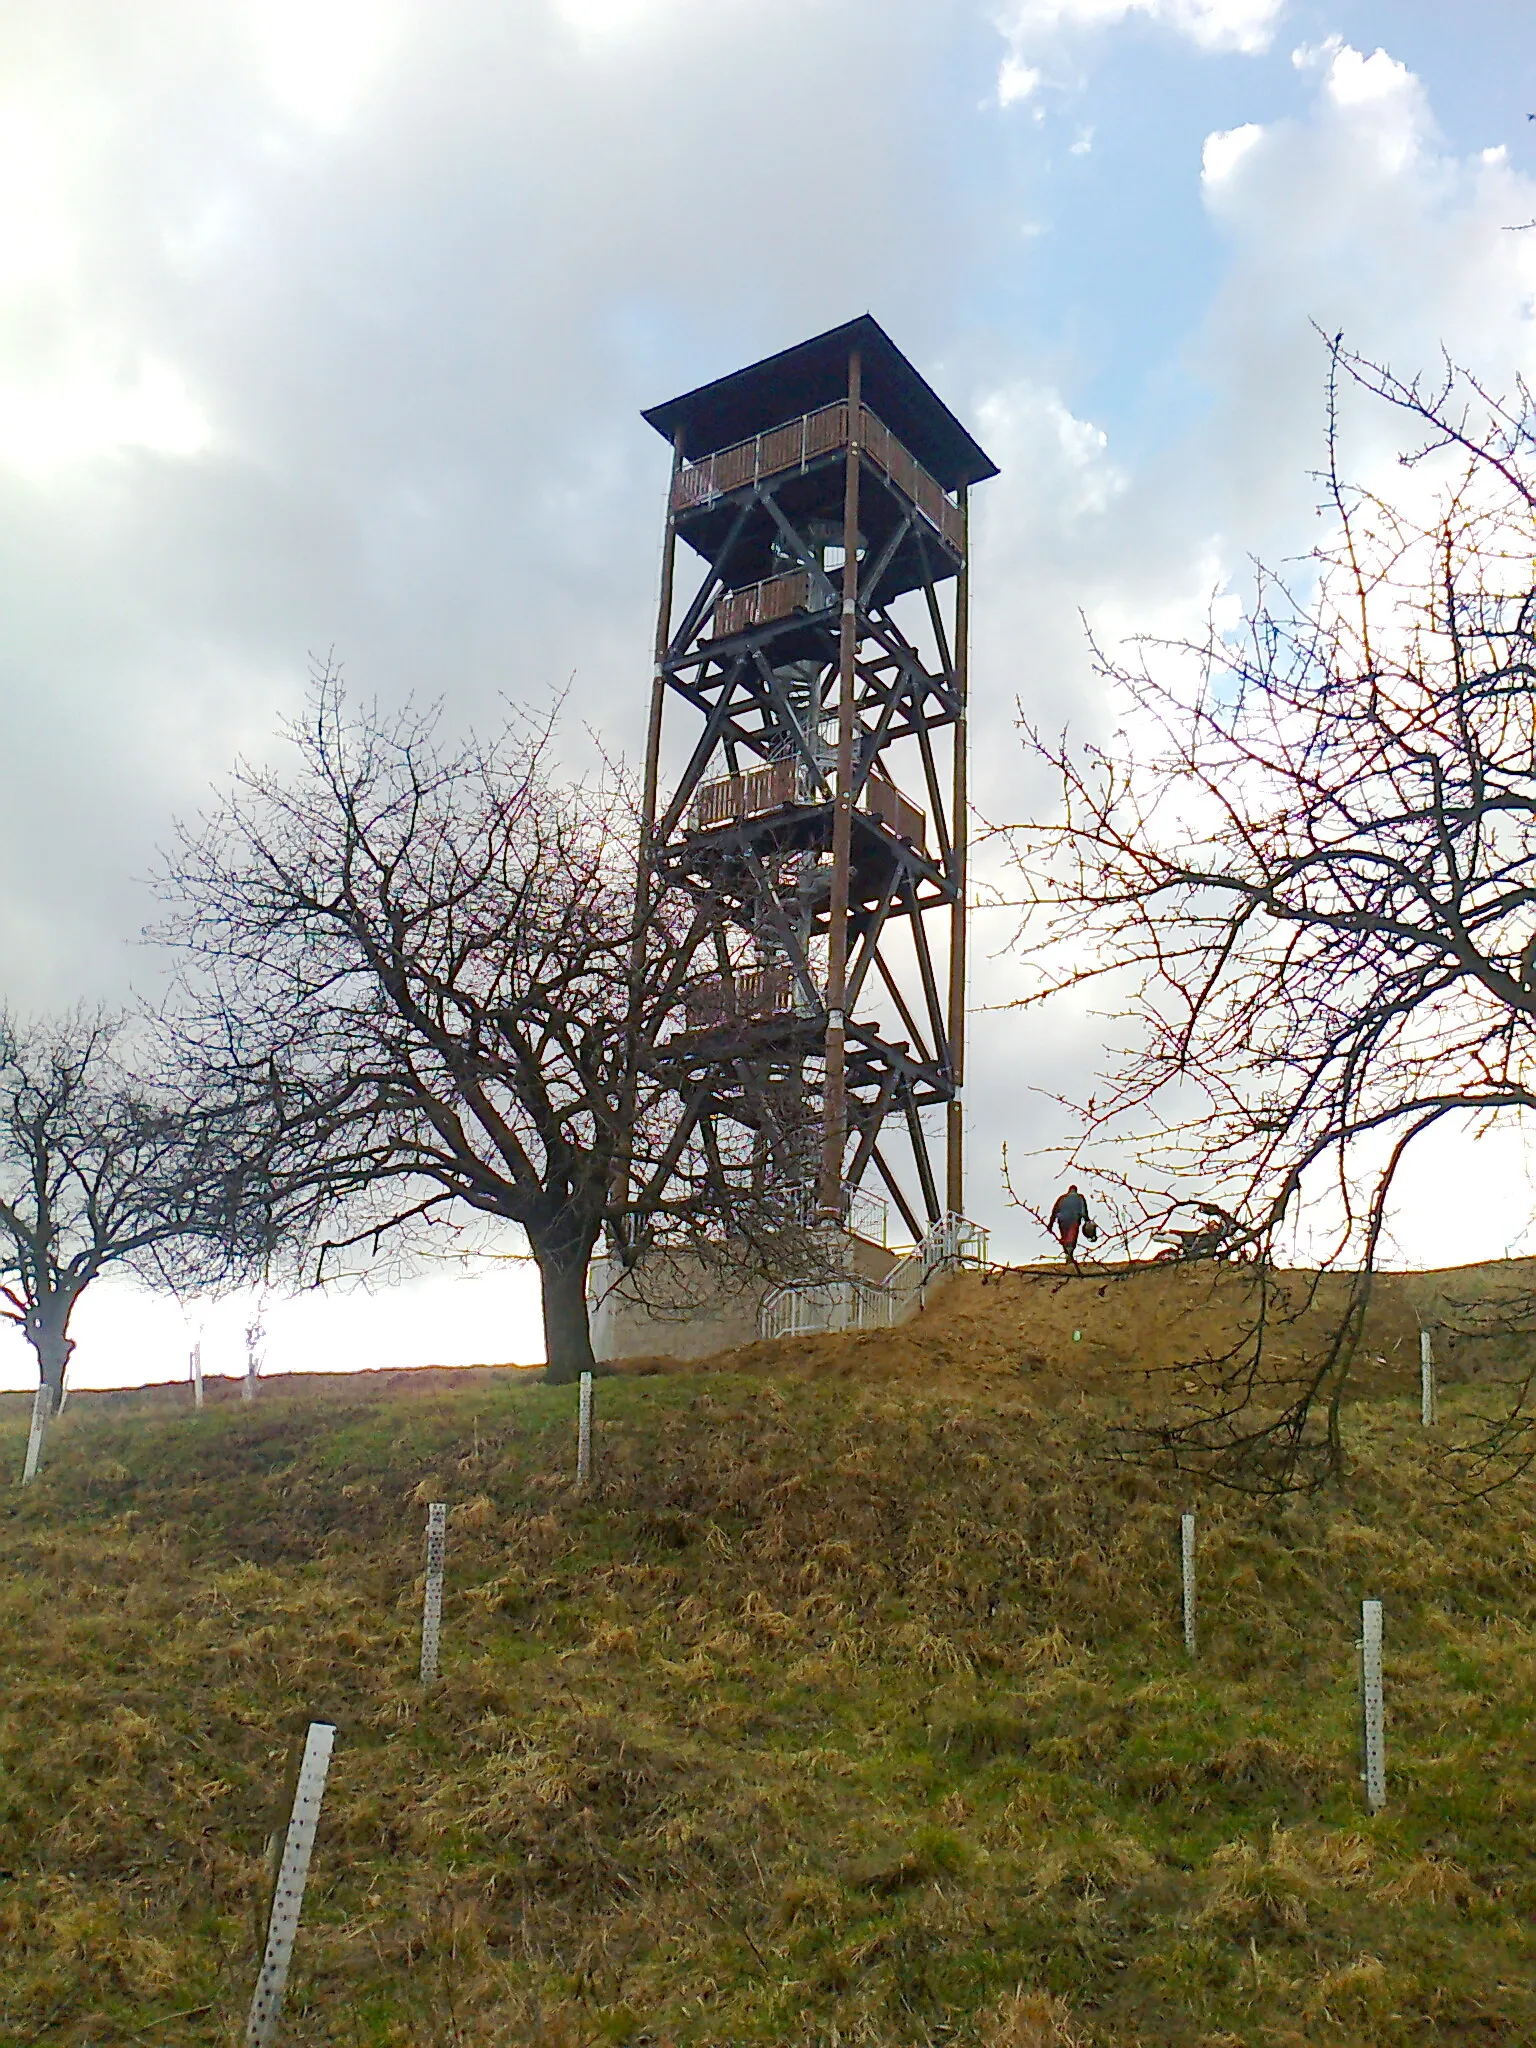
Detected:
[{"left": 641, "top": 313, "right": 997, "bottom": 492}]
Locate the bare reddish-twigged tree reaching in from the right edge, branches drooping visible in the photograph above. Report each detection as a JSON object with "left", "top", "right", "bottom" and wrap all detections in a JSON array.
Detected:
[{"left": 1016, "top": 340, "right": 1536, "bottom": 1487}]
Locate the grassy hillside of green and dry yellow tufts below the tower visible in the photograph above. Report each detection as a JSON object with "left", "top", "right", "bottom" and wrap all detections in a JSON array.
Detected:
[{"left": 0, "top": 1280, "right": 1536, "bottom": 2048}]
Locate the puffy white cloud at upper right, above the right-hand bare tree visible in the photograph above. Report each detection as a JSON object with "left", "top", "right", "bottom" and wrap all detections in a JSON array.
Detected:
[{"left": 1165, "top": 37, "right": 1536, "bottom": 643}]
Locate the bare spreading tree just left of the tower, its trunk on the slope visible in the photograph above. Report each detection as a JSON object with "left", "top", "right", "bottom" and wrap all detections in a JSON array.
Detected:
[{"left": 164, "top": 670, "right": 819, "bottom": 1380}]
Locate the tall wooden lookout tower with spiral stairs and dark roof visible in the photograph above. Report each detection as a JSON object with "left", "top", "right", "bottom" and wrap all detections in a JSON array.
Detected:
[{"left": 641, "top": 315, "right": 997, "bottom": 1237}]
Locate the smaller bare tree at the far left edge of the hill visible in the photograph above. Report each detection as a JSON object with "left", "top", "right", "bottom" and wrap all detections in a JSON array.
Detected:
[{"left": 0, "top": 1010, "right": 240, "bottom": 1411}]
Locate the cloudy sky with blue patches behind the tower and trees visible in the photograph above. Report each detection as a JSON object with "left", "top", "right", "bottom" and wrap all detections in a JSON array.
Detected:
[{"left": 0, "top": 0, "right": 1536, "bottom": 1384}]
